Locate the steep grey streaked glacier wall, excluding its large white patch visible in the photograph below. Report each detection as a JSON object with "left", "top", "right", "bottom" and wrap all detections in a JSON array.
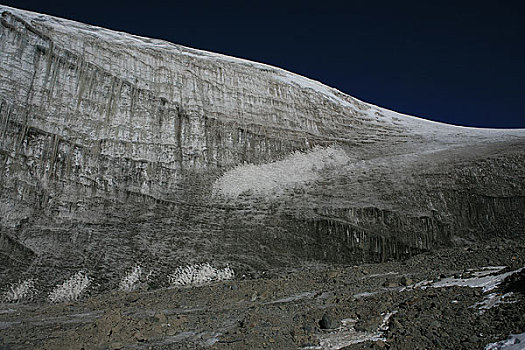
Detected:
[{"left": 0, "top": 6, "right": 525, "bottom": 288}]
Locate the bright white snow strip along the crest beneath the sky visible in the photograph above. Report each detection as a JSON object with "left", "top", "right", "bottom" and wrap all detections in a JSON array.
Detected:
[{"left": 0, "top": 5, "right": 525, "bottom": 137}]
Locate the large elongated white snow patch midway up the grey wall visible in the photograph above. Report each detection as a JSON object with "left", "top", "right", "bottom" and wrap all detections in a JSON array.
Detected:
[{"left": 213, "top": 147, "right": 350, "bottom": 197}]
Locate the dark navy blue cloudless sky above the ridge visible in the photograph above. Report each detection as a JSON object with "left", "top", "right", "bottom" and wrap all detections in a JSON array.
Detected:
[{"left": 0, "top": 0, "right": 525, "bottom": 128}]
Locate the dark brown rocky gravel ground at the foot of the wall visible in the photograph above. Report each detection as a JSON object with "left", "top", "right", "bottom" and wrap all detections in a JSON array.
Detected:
[{"left": 0, "top": 238, "right": 525, "bottom": 349}]
